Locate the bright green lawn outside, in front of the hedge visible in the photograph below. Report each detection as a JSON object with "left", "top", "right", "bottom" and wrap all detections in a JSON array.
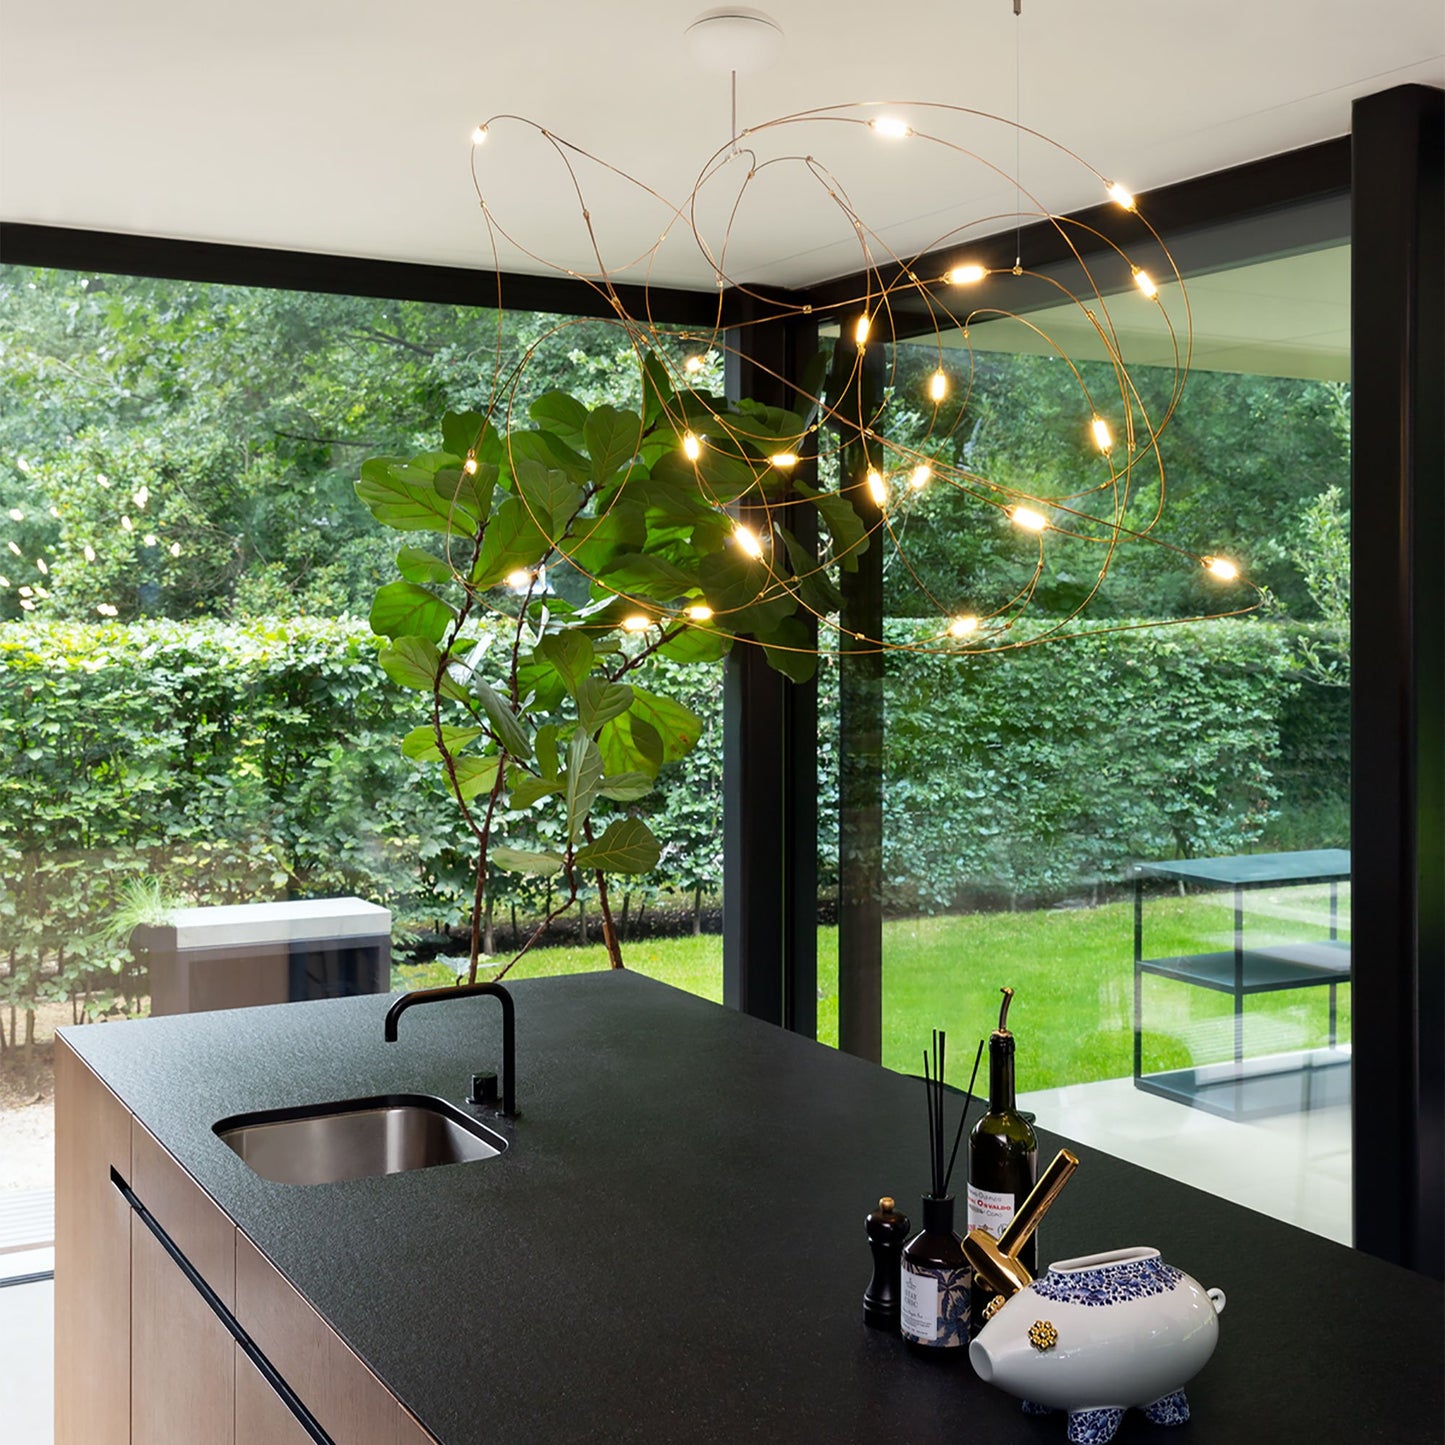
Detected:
[{"left": 407, "top": 889, "right": 1350, "bottom": 1090}]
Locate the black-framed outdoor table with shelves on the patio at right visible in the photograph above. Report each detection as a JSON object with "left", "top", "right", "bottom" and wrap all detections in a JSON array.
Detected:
[{"left": 1134, "top": 848, "right": 1350, "bottom": 1118}]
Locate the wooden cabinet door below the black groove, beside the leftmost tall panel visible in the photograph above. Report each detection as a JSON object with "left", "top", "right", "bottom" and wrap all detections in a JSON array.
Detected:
[{"left": 130, "top": 1215, "right": 236, "bottom": 1445}]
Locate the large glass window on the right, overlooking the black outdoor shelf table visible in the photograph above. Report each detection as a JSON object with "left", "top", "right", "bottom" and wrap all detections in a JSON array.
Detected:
[{"left": 819, "top": 231, "right": 1350, "bottom": 1241}]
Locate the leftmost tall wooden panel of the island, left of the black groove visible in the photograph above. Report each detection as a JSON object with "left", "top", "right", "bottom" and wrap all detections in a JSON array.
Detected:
[{"left": 55, "top": 1036, "right": 130, "bottom": 1445}]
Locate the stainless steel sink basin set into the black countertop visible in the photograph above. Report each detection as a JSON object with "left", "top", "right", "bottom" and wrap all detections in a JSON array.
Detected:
[{"left": 214, "top": 1094, "right": 507, "bottom": 1183}]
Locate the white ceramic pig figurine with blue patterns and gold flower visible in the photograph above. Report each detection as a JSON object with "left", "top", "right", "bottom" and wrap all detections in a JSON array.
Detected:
[{"left": 968, "top": 1248, "right": 1224, "bottom": 1445}]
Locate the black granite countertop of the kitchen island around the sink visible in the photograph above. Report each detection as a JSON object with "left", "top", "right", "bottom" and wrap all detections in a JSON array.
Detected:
[{"left": 66, "top": 972, "right": 1445, "bottom": 1445}]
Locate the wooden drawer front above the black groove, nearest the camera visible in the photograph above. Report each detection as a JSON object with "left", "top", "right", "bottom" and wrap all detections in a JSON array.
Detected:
[{"left": 236, "top": 1231, "right": 401, "bottom": 1445}]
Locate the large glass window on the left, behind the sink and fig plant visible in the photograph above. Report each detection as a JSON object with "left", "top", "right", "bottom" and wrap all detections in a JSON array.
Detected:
[{"left": 0, "top": 267, "right": 734, "bottom": 1192}]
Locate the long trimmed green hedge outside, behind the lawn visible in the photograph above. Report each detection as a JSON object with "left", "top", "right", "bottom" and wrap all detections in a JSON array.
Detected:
[{"left": 0, "top": 620, "right": 1348, "bottom": 1009}]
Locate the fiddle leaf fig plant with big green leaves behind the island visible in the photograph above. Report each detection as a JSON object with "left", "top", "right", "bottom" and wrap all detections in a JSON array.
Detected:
[{"left": 357, "top": 354, "right": 858, "bottom": 981}]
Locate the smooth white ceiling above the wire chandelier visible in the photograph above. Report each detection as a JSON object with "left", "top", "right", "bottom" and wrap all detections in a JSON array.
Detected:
[{"left": 0, "top": 0, "right": 1445, "bottom": 286}]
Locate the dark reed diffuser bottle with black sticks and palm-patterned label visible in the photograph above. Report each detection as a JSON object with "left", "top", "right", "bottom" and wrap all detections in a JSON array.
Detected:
[{"left": 899, "top": 1030, "right": 983, "bottom": 1357}]
